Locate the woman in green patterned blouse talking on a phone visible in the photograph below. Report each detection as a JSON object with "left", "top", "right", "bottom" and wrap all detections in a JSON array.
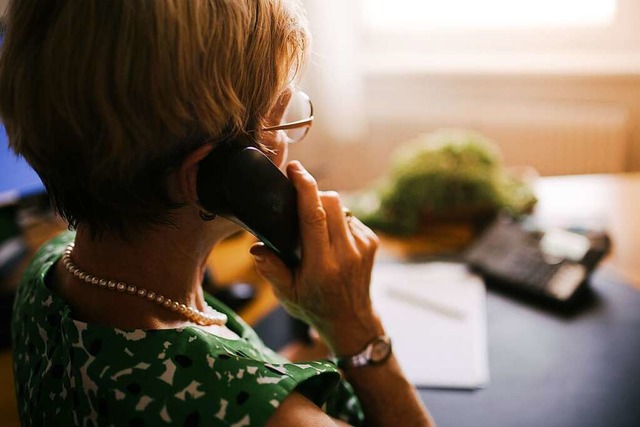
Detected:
[{"left": 0, "top": 0, "right": 430, "bottom": 426}]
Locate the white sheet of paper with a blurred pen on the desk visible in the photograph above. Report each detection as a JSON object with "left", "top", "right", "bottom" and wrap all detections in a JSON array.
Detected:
[{"left": 371, "top": 262, "right": 489, "bottom": 388}]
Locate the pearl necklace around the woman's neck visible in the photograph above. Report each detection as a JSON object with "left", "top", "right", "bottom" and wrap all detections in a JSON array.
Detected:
[{"left": 62, "top": 243, "right": 227, "bottom": 326}]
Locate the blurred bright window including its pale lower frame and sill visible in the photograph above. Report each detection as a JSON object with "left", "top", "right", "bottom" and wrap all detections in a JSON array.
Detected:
[{"left": 358, "top": 0, "right": 640, "bottom": 74}]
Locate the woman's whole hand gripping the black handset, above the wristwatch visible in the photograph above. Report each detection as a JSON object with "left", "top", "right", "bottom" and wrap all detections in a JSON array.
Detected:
[{"left": 251, "top": 162, "right": 383, "bottom": 355}]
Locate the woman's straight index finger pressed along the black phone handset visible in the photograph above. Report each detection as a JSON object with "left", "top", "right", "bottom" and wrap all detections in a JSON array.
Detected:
[{"left": 287, "top": 161, "right": 330, "bottom": 265}]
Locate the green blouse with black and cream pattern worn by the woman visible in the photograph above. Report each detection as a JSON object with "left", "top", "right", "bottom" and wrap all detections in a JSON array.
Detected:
[{"left": 12, "top": 232, "right": 363, "bottom": 427}]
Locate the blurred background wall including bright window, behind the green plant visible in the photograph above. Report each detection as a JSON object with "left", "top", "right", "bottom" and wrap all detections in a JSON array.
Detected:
[{"left": 292, "top": 0, "right": 640, "bottom": 189}]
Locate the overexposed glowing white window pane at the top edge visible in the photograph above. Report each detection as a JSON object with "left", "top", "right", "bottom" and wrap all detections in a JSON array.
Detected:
[{"left": 362, "top": 0, "right": 617, "bottom": 30}]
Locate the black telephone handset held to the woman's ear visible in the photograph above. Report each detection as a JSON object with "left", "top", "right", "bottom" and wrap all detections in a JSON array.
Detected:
[{"left": 197, "top": 136, "right": 300, "bottom": 267}]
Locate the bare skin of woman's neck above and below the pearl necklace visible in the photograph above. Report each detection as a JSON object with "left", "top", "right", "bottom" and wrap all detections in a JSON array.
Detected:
[{"left": 55, "top": 214, "right": 239, "bottom": 329}]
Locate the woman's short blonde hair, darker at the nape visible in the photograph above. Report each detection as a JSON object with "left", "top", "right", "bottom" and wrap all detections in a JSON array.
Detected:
[{"left": 0, "top": 0, "right": 308, "bottom": 231}]
